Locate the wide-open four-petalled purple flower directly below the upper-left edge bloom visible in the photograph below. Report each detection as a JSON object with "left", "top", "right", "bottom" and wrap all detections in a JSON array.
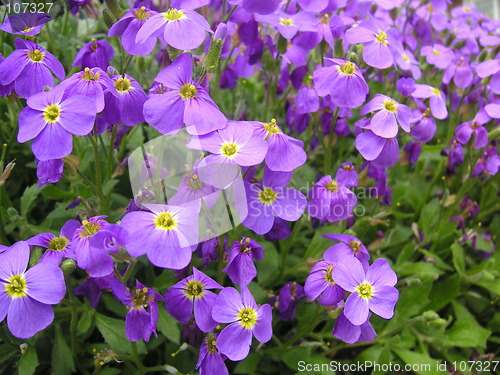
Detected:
[{"left": 17, "top": 86, "right": 96, "bottom": 161}]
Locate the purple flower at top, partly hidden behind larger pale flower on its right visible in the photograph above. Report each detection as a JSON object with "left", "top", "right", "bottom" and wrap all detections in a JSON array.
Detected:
[{"left": 108, "top": 6, "right": 157, "bottom": 56}]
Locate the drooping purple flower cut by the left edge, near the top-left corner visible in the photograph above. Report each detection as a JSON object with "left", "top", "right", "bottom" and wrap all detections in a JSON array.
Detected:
[{"left": 0, "top": 38, "right": 65, "bottom": 99}]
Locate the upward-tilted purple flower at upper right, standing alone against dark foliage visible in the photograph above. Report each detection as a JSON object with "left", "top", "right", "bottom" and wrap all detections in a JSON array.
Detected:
[{"left": 313, "top": 58, "right": 369, "bottom": 108}]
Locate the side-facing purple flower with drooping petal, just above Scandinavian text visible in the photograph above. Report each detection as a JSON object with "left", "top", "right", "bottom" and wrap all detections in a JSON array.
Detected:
[{"left": 252, "top": 119, "right": 307, "bottom": 172}]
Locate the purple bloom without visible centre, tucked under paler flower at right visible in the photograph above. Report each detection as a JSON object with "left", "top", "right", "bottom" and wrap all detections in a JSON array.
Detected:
[{"left": 356, "top": 130, "right": 399, "bottom": 168}]
